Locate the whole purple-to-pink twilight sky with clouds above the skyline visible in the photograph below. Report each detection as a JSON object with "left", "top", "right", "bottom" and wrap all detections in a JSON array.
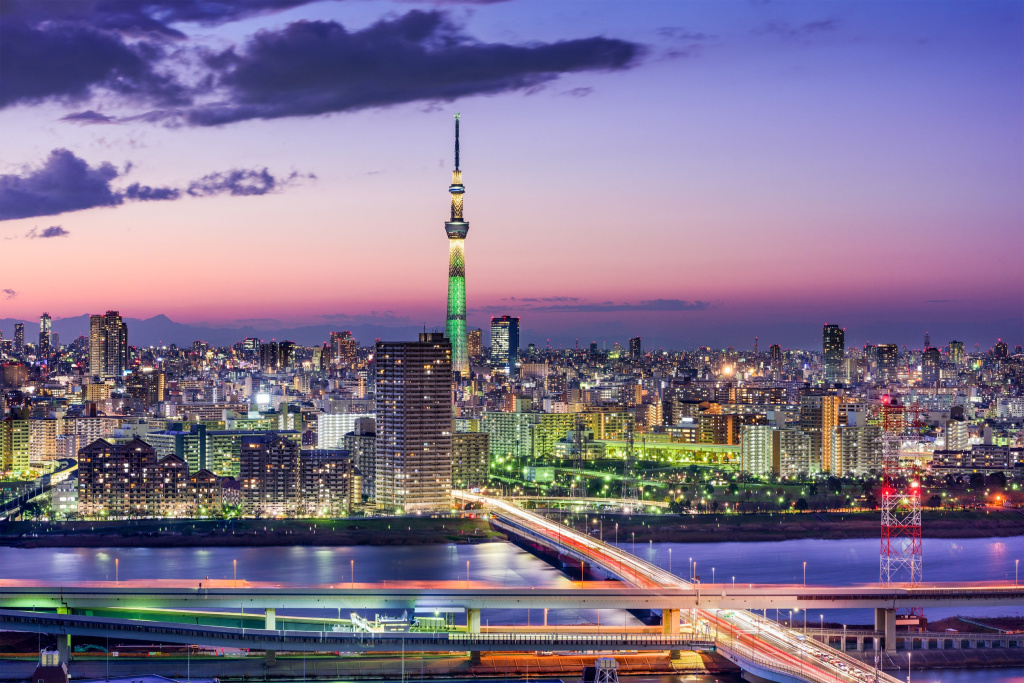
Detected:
[{"left": 0, "top": 0, "right": 1024, "bottom": 348}]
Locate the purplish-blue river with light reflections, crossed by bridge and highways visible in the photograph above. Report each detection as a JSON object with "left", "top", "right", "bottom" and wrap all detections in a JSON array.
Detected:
[{"left": 0, "top": 537, "right": 1024, "bottom": 683}]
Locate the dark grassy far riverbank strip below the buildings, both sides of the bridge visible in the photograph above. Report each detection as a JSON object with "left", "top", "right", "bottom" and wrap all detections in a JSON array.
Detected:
[{"left": 0, "top": 508, "right": 1024, "bottom": 548}]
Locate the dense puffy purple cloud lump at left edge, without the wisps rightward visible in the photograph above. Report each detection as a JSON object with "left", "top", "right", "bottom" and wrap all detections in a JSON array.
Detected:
[{"left": 0, "top": 150, "right": 123, "bottom": 220}]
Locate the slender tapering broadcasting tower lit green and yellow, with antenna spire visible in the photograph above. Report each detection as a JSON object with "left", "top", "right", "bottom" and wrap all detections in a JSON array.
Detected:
[{"left": 444, "top": 114, "right": 469, "bottom": 379}]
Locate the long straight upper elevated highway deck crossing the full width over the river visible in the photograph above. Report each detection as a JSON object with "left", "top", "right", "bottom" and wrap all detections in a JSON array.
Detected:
[{"left": 0, "top": 585, "right": 1024, "bottom": 612}]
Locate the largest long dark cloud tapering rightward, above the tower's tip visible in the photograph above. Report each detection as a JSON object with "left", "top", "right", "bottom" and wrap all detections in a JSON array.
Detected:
[{"left": 175, "top": 10, "right": 642, "bottom": 126}]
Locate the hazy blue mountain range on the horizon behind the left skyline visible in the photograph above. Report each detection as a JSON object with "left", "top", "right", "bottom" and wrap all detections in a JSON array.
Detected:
[{"left": 0, "top": 314, "right": 422, "bottom": 346}]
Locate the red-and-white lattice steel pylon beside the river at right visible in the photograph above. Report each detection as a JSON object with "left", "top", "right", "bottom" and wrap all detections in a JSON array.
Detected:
[{"left": 879, "top": 397, "right": 923, "bottom": 612}]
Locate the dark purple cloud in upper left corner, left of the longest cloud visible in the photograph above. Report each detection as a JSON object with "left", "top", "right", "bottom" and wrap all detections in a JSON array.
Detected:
[{"left": 0, "top": 19, "right": 188, "bottom": 109}]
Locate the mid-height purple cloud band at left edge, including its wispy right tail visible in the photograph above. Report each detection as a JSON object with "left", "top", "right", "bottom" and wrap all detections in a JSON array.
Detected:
[{"left": 0, "top": 150, "right": 314, "bottom": 220}]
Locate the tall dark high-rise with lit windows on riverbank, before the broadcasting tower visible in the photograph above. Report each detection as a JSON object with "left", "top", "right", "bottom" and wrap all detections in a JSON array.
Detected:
[{"left": 375, "top": 331, "right": 452, "bottom": 512}]
